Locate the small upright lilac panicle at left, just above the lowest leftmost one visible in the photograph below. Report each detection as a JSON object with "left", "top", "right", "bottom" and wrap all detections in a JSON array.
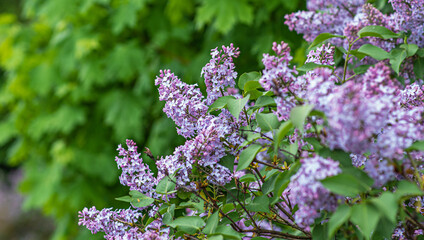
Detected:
[{"left": 115, "top": 139, "right": 157, "bottom": 196}]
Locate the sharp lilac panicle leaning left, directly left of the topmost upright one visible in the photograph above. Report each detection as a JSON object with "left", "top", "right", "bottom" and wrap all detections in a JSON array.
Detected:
[{"left": 155, "top": 70, "right": 208, "bottom": 138}]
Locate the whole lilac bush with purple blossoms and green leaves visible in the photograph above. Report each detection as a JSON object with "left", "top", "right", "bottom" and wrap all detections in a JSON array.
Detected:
[{"left": 79, "top": 0, "right": 424, "bottom": 239}]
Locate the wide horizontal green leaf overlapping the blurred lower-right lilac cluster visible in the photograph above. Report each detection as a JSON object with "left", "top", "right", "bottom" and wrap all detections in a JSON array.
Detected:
[{"left": 321, "top": 173, "right": 371, "bottom": 197}]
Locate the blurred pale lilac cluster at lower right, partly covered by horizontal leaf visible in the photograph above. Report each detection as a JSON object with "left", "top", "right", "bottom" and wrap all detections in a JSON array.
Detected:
[{"left": 283, "top": 156, "right": 341, "bottom": 226}]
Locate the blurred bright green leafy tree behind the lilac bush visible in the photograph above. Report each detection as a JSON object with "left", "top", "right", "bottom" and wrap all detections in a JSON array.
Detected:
[{"left": 0, "top": 0, "right": 305, "bottom": 239}]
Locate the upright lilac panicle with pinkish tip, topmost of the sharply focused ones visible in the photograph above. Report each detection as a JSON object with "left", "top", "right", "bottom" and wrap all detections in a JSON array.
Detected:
[{"left": 201, "top": 43, "right": 240, "bottom": 105}]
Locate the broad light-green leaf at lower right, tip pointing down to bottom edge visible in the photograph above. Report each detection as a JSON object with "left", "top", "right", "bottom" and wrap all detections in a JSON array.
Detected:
[{"left": 350, "top": 203, "right": 380, "bottom": 239}]
